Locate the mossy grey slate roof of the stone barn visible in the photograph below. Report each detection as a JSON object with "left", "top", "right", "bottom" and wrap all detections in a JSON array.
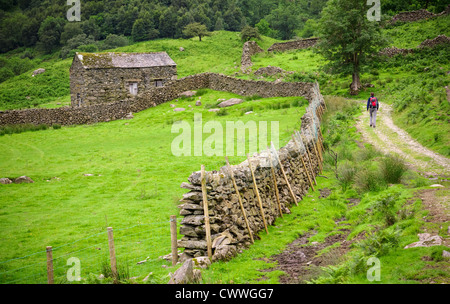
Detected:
[{"left": 75, "top": 52, "right": 177, "bottom": 69}]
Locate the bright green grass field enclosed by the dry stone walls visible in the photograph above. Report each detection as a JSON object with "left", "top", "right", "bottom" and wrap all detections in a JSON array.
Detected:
[{"left": 0, "top": 90, "right": 307, "bottom": 282}]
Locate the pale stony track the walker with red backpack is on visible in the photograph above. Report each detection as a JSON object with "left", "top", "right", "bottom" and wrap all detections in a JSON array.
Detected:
[{"left": 356, "top": 102, "right": 450, "bottom": 176}]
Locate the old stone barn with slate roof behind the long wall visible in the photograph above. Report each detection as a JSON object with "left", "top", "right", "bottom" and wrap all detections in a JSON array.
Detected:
[{"left": 70, "top": 52, "right": 177, "bottom": 107}]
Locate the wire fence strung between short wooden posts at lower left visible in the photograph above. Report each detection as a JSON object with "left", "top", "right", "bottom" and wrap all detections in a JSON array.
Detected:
[{"left": 0, "top": 218, "right": 182, "bottom": 284}]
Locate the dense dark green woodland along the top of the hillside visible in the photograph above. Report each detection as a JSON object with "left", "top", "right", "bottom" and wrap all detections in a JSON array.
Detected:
[{"left": 0, "top": 0, "right": 447, "bottom": 57}]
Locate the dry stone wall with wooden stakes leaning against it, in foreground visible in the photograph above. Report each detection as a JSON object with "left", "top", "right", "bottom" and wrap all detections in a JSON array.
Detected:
[{"left": 174, "top": 83, "right": 324, "bottom": 261}]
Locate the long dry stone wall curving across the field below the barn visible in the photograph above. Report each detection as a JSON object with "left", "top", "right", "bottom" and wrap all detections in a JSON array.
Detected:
[{"left": 0, "top": 73, "right": 313, "bottom": 126}]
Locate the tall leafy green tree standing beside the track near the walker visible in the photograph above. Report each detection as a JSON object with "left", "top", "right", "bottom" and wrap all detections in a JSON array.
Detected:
[{"left": 317, "top": 0, "right": 386, "bottom": 94}]
